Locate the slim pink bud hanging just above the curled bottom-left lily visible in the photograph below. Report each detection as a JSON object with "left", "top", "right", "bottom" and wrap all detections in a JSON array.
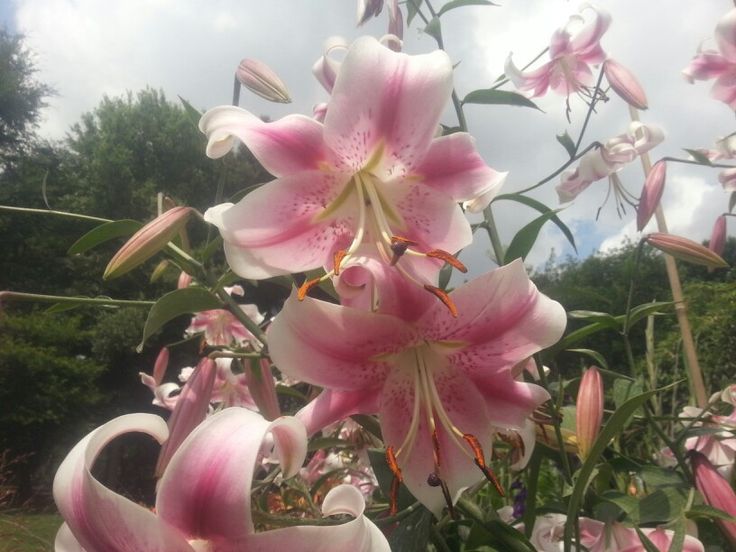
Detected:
[{"left": 156, "top": 358, "right": 217, "bottom": 477}]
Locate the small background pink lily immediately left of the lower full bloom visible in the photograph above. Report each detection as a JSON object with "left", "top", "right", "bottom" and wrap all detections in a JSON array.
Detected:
[{"left": 184, "top": 286, "right": 264, "bottom": 348}]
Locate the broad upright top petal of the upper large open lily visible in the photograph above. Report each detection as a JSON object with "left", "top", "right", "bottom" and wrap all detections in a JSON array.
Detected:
[{"left": 324, "top": 37, "right": 452, "bottom": 179}]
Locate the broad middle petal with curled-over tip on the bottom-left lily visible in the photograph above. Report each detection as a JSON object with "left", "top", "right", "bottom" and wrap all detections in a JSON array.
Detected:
[{"left": 156, "top": 408, "right": 307, "bottom": 547}]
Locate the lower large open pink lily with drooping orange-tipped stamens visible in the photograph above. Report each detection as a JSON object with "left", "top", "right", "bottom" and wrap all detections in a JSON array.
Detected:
[{"left": 268, "top": 261, "right": 566, "bottom": 515}]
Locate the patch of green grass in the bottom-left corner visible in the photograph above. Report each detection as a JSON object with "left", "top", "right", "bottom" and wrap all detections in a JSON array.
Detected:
[{"left": 0, "top": 510, "right": 62, "bottom": 552}]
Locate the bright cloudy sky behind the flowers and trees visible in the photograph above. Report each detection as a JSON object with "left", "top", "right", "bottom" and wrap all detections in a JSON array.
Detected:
[{"left": 0, "top": 0, "right": 735, "bottom": 273}]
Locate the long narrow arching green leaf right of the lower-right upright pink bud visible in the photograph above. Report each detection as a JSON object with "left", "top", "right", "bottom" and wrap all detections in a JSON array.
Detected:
[{"left": 565, "top": 387, "right": 668, "bottom": 552}]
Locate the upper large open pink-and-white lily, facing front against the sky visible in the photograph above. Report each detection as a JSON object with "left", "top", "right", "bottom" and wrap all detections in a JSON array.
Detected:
[{"left": 200, "top": 37, "right": 505, "bottom": 308}]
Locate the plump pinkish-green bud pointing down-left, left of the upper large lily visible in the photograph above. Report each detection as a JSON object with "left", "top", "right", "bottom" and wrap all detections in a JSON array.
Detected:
[{"left": 102, "top": 207, "right": 193, "bottom": 280}]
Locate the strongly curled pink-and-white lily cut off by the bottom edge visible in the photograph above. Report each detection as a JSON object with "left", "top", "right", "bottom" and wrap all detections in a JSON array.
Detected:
[{"left": 54, "top": 408, "right": 389, "bottom": 552}]
